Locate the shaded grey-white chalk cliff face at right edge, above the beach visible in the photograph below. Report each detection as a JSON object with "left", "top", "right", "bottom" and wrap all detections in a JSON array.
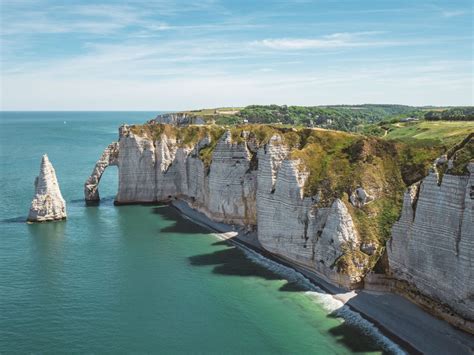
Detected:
[{"left": 387, "top": 163, "right": 474, "bottom": 322}]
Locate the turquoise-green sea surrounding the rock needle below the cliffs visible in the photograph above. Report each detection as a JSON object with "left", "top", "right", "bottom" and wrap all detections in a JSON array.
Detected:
[{"left": 0, "top": 112, "right": 399, "bottom": 354}]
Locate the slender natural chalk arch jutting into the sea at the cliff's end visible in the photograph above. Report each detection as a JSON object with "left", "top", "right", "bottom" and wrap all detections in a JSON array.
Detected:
[{"left": 84, "top": 142, "right": 119, "bottom": 202}]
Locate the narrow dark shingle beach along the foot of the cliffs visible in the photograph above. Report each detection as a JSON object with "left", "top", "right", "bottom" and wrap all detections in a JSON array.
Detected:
[{"left": 170, "top": 199, "right": 474, "bottom": 354}]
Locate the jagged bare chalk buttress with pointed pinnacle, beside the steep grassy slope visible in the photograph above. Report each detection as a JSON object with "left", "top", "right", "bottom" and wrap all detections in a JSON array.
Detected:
[{"left": 257, "top": 138, "right": 364, "bottom": 287}]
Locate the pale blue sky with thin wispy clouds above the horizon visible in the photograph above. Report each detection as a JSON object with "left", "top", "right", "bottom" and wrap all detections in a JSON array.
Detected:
[{"left": 0, "top": 0, "right": 474, "bottom": 111}]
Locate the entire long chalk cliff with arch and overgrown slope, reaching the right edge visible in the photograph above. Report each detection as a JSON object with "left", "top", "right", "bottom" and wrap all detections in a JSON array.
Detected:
[{"left": 85, "top": 123, "right": 474, "bottom": 328}]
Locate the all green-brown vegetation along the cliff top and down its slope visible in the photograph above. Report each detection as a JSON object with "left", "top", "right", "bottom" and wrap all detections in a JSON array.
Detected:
[{"left": 131, "top": 121, "right": 474, "bottom": 273}]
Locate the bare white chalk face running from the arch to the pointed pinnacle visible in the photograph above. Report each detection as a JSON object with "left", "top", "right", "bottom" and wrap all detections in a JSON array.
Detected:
[{"left": 85, "top": 126, "right": 364, "bottom": 287}]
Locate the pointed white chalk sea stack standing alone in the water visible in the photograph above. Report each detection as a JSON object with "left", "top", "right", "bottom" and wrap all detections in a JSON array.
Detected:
[{"left": 27, "top": 154, "right": 66, "bottom": 222}]
